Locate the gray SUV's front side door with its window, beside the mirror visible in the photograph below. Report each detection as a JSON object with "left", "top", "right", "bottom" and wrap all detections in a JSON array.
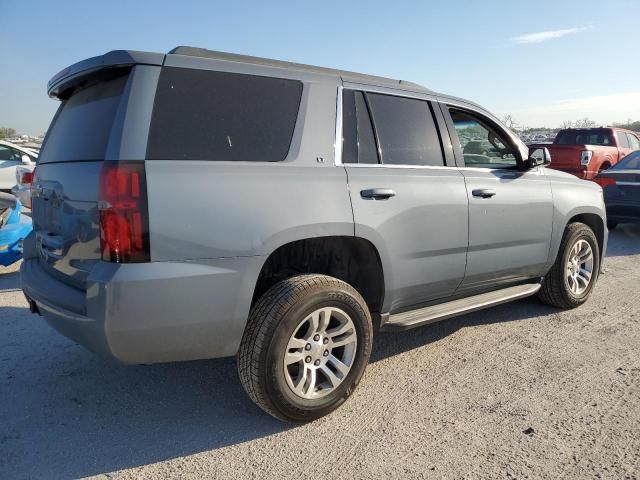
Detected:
[{"left": 442, "top": 104, "right": 553, "bottom": 293}]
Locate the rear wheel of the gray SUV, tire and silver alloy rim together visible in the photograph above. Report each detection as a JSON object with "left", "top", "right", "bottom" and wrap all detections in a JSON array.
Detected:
[{"left": 238, "top": 275, "right": 373, "bottom": 422}]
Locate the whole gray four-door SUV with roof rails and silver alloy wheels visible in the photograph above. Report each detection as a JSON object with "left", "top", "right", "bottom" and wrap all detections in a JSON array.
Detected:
[{"left": 21, "top": 47, "right": 607, "bottom": 422}]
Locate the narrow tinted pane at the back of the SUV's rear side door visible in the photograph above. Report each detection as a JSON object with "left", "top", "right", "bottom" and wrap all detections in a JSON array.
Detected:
[{"left": 342, "top": 90, "right": 378, "bottom": 163}]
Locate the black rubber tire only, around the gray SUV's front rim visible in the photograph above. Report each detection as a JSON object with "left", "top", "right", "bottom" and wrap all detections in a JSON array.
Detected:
[{"left": 538, "top": 223, "right": 600, "bottom": 309}]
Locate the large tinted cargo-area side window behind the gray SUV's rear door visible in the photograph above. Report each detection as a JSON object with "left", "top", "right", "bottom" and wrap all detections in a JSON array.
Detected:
[{"left": 147, "top": 67, "right": 302, "bottom": 162}]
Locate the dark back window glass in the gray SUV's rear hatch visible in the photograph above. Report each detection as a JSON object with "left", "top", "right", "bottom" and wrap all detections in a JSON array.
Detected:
[{"left": 38, "top": 70, "right": 128, "bottom": 163}]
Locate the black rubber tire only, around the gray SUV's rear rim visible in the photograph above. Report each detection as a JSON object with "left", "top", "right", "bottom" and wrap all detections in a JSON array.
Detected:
[{"left": 238, "top": 275, "right": 373, "bottom": 423}]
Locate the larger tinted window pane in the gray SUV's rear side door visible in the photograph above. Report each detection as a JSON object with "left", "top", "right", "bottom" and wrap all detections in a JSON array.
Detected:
[{"left": 367, "top": 93, "right": 444, "bottom": 166}]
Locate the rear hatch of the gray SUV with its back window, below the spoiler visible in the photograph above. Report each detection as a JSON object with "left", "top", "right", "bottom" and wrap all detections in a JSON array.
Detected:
[{"left": 32, "top": 63, "right": 159, "bottom": 289}]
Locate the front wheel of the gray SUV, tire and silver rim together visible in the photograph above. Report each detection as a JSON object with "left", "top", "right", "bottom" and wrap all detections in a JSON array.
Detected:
[{"left": 538, "top": 223, "right": 600, "bottom": 309}]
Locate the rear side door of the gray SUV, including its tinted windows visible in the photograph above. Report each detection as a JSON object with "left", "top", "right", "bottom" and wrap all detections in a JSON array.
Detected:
[{"left": 341, "top": 86, "right": 468, "bottom": 312}]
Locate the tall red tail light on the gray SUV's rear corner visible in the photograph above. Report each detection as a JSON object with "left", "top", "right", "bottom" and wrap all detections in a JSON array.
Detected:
[{"left": 98, "top": 161, "right": 150, "bottom": 263}]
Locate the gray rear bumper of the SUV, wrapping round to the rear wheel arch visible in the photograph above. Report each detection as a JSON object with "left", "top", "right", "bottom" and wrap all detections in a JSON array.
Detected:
[{"left": 21, "top": 257, "right": 261, "bottom": 363}]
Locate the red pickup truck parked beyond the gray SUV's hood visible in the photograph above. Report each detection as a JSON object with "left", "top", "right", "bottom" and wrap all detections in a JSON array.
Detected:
[{"left": 530, "top": 128, "right": 640, "bottom": 180}]
